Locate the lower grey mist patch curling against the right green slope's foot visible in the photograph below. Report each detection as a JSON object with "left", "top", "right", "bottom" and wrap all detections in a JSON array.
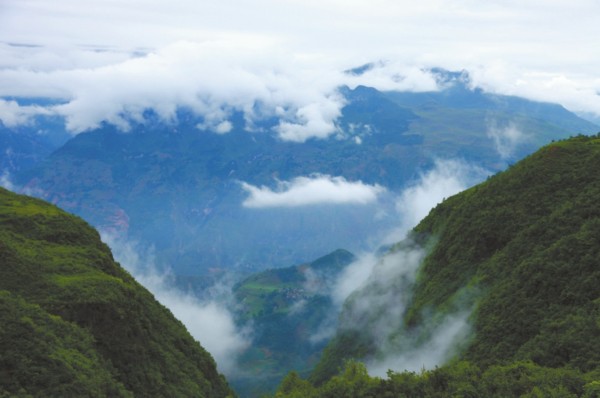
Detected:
[{"left": 340, "top": 239, "right": 471, "bottom": 377}]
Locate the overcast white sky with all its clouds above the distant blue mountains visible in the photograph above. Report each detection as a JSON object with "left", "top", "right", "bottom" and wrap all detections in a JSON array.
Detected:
[{"left": 0, "top": 0, "right": 600, "bottom": 138}]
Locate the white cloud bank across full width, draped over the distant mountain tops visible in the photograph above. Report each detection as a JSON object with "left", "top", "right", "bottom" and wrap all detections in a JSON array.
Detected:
[{"left": 0, "top": 38, "right": 600, "bottom": 142}]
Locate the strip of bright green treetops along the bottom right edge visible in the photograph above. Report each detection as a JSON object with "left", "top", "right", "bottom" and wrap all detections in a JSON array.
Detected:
[{"left": 274, "top": 361, "right": 600, "bottom": 398}]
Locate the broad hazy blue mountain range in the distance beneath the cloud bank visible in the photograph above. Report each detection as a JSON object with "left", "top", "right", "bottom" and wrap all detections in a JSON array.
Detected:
[{"left": 15, "top": 76, "right": 598, "bottom": 276}]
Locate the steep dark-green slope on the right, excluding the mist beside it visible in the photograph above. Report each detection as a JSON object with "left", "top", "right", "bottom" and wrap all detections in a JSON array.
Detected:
[{"left": 300, "top": 137, "right": 600, "bottom": 396}]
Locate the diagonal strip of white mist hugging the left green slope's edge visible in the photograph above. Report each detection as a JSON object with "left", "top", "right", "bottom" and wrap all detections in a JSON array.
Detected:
[{"left": 102, "top": 234, "right": 251, "bottom": 376}]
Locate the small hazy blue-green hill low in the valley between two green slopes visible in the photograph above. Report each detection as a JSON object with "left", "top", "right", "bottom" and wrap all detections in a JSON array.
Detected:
[{"left": 229, "top": 249, "right": 355, "bottom": 397}]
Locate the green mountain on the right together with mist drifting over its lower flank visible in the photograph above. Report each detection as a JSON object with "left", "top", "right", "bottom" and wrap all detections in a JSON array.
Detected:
[{"left": 278, "top": 135, "right": 600, "bottom": 397}]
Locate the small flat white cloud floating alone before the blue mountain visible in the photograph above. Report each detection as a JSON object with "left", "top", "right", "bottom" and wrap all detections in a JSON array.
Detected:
[{"left": 242, "top": 174, "right": 385, "bottom": 208}]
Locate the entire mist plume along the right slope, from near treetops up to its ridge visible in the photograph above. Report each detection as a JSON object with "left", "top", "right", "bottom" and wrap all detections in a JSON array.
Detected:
[{"left": 313, "top": 159, "right": 489, "bottom": 377}]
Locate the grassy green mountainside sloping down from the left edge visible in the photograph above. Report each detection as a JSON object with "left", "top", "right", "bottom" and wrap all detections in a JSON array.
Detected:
[{"left": 0, "top": 188, "right": 233, "bottom": 397}]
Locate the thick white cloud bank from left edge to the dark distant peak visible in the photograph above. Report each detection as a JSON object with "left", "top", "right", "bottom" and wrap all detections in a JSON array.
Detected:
[{"left": 0, "top": 40, "right": 437, "bottom": 142}]
